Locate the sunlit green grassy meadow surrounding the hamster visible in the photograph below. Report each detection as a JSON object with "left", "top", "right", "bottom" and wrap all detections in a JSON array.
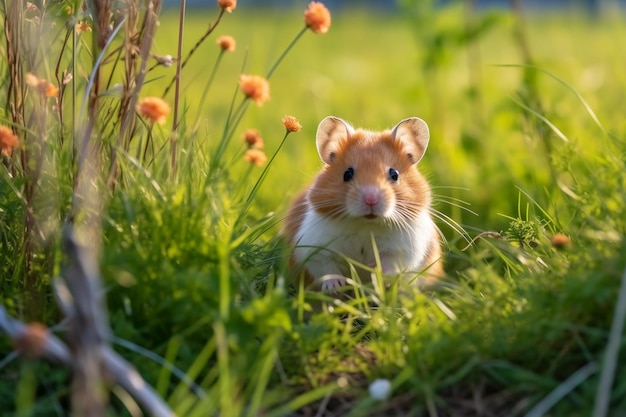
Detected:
[{"left": 0, "top": 0, "right": 626, "bottom": 417}]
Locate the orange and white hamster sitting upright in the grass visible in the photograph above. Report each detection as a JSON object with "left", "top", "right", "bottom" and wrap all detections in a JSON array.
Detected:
[{"left": 281, "top": 116, "right": 443, "bottom": 293}]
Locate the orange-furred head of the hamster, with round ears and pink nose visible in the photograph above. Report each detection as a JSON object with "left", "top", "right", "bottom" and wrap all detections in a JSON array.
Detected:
[{"left": 308, "top": 116, "right": 431, "bottom": 226}]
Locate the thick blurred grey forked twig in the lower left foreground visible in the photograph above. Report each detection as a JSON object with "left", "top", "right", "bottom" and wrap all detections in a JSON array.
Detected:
[{"left": 0, "top": 226, "right": 174, "bottom": 417}]
